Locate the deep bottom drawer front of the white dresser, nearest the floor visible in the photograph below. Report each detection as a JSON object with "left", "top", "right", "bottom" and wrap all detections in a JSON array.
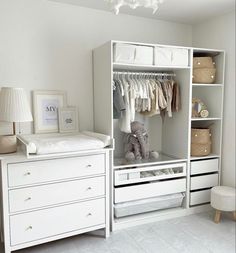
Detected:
[{"left": 10, "top": 199, "right": 105, "bottom": 246}]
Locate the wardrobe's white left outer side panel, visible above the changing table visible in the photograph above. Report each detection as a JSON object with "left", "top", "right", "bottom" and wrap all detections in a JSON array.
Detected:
[{"left": 93, "top": 42, "right": 113, "bottom": 137}]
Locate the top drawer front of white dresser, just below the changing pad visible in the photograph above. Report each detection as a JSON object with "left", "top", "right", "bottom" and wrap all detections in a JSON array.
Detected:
[{"left": 8, "top": 154, "right": 105, "bottom": 187}]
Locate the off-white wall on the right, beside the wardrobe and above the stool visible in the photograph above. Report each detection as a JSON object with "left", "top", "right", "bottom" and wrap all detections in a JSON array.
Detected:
[{"left": 193, "top": 11, "right": 236, "bottom": 186}]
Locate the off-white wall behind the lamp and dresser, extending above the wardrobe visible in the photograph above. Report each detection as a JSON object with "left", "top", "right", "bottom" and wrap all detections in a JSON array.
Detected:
[{"left": 0, "top": 0, "right": 191, "bottom": 132}]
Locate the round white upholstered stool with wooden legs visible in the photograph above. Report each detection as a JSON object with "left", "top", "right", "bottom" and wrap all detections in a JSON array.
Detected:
[{"left": 211, "top": 186, "right": 236, "bottom": 223}]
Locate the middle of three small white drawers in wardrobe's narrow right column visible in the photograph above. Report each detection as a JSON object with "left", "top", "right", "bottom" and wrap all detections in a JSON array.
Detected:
[{"left": 191, "top": 174, "right": 218, "bottom": 190}]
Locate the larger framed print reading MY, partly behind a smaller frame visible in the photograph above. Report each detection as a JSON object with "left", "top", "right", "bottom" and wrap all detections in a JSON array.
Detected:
[{"left": 33, "top": 90, "right": 66, "bottom": 133}]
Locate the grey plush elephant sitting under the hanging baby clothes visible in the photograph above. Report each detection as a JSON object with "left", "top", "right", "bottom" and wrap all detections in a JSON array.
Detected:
[{"left": 124, "top": 121, "right": 159, "bottom": 161}]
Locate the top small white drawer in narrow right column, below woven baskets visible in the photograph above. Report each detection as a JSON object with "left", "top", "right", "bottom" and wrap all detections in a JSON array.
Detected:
[{"left": 191, "top": 159, "right": 219, "bottom": 175}]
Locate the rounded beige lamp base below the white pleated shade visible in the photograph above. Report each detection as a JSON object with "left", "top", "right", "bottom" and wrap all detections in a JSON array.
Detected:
[{"left": 0, "top": 135, "right": 17, "bottom": 154}]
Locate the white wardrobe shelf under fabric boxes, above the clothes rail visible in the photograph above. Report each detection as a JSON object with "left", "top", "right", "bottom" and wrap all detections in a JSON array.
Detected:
[{"left": 113, "top": 63, "right": 190, "bottom": 71}]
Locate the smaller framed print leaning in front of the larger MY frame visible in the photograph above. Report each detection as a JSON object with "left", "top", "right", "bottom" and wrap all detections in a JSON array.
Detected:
[{"left": 58, "top": 106, "right": 79, "bottom": 133}]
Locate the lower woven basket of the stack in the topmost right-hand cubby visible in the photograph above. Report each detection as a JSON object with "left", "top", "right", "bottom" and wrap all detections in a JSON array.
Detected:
[{"left": 193, "top": 68, "right": 216, "bottom": 83}]
